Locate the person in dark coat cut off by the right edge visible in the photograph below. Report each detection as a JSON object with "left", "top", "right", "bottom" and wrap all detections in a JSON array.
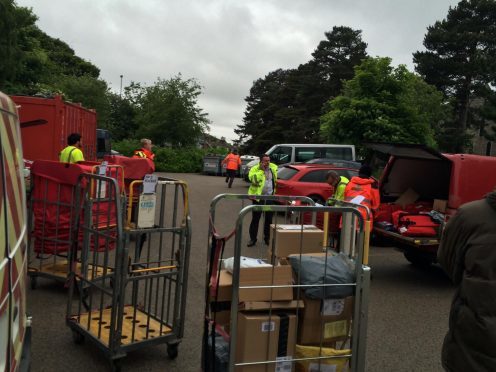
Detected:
[{"left": 438, "top": 189, "right": 496, "bottom": 372}]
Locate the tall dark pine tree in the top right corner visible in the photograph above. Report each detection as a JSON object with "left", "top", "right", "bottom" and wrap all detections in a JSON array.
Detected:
[{"left": 414, "top": 0, "right": 496, "bottom": 152}]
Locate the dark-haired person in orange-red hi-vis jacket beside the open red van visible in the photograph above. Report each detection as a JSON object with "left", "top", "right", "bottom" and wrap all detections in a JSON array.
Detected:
[{"left": 344, "top": 165, "right": 381, "bottom": 224}]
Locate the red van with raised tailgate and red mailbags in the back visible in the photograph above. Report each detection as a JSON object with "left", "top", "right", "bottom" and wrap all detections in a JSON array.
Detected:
[{"left": 367, "top": 143, "right": 496, "bottom": 265}]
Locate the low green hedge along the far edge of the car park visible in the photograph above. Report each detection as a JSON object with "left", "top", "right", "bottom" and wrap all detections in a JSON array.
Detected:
[{"left": 112, "top": 139, "right": 228, "bottom": 173}]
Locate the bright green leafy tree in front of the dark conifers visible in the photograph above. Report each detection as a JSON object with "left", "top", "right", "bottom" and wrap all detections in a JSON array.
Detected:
[{"left": 321, "top": 58, "right": 445, "bottom": 155}]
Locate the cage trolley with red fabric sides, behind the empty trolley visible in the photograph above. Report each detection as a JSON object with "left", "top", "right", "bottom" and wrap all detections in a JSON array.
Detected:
[{"left": 28, "top": 160, "right": 124, "bottom": 289}]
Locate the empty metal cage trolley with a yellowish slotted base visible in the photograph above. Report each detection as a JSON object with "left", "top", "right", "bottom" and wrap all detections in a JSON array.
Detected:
[{"left": 66, "top": 174, "right": 191, "bottom": 371}]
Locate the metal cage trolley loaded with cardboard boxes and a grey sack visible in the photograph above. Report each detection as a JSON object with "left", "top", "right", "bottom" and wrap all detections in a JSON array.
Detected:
[{"left": 204, "top": 196, "right": 370, "bottom": 372}]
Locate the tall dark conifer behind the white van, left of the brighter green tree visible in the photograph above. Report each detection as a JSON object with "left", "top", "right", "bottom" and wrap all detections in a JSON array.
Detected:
[{"left": 235, "top": 26, "right": 367, "bottom": 152}]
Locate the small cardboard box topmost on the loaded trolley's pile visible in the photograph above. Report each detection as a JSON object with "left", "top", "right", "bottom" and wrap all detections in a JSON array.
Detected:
[{"left": 269, "top": 225, "right": 324, "bottom": 257}]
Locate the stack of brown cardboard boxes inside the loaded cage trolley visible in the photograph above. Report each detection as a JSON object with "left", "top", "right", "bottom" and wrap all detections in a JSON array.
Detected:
[{"left": 210, "top": 225, "right": 353, "bottom": 372}]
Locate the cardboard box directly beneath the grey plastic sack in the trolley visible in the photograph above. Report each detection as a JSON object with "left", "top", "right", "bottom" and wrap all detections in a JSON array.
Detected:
[{"left": 298, "top": 295, "right": 353, "bottom": 345}]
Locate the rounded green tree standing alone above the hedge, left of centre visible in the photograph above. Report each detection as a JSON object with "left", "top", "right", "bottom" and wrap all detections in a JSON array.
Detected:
[{"left": 130, "top": 74, "right": 210, "bottom": 146}]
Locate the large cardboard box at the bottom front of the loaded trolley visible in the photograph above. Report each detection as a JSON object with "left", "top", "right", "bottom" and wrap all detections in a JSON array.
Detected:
[{"left": 235, "top": 312, "right": 296, "bottom": 372}]
